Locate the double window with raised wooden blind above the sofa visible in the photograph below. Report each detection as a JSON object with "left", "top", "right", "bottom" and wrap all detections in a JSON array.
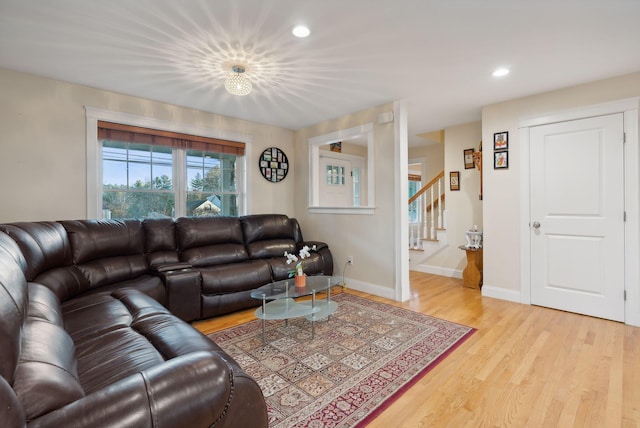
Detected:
[{"left": 98, "top": 121, "right": 244, "bottom": 218}]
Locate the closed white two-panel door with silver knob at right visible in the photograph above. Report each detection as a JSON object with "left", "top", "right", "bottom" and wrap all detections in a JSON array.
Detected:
[{"left": 530, "top": 114, "right": 625, "bottom": 321}]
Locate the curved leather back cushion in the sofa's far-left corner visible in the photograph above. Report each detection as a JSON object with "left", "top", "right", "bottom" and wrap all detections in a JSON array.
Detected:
[{"left": 0, "top": 221, "right": 72, "bottom": 281}]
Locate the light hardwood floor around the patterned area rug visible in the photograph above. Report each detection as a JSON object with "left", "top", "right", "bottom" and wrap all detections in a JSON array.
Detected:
[{"left": 194, "top": 272, "right": 640, "bottom": 428}]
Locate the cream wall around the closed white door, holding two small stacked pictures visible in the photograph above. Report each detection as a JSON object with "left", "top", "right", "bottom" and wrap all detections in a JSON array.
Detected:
[{"left": 482, "top": 72, "right": 640, "bottom": 301}]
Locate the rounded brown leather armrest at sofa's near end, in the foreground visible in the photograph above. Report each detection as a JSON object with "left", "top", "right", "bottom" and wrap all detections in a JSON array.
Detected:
[{"left": 29, "top": 351, "right": 267, "bottom": 428}]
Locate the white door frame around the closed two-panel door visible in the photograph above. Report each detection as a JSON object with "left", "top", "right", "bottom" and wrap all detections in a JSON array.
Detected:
[{"left": 519, "top": 97, "right": 640, "bottom": 326}]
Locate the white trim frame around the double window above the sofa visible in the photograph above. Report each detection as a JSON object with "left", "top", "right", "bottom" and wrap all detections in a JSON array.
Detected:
[{"left": 85, "top": 106, "right": 252, "bottom": 219}]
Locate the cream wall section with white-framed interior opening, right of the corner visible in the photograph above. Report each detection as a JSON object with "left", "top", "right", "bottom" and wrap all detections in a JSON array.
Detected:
[{"left": 295, "top": 104, "right": 396, "bottom": 298}]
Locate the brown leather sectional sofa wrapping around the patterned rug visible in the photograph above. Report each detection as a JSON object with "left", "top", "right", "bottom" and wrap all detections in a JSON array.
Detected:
[{"left": 0, "top": 215, "right": 333, "bottom": 427}]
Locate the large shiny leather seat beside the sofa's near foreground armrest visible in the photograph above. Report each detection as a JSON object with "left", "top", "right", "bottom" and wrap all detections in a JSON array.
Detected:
[{"left": 63, "top": 289, "right": 219, "bottom": 394}]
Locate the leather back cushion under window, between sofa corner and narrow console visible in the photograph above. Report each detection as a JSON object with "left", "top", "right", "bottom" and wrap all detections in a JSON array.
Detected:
[{"left": 61, "top": 220, "right": 148, "bottom": 288}]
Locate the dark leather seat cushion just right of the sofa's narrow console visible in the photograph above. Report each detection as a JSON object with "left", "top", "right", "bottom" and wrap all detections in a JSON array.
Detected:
[{"left": 200, "top": 260, "right": 271, "bottom": 295}]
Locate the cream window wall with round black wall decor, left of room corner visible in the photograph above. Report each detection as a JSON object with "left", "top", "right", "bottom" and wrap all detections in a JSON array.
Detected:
[{"left": 0, "top": 69, "right": 295, "bottom": 222}]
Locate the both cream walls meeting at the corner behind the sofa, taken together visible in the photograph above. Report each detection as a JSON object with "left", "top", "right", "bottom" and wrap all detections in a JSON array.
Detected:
[{"left": 0, "top": 69, "right": 396, "bottom": 298}]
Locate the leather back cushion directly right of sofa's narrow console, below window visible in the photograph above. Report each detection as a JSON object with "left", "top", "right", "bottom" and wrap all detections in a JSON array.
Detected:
[{"left": 176, "top": 217, "right": 248, "bottom": 267}]
